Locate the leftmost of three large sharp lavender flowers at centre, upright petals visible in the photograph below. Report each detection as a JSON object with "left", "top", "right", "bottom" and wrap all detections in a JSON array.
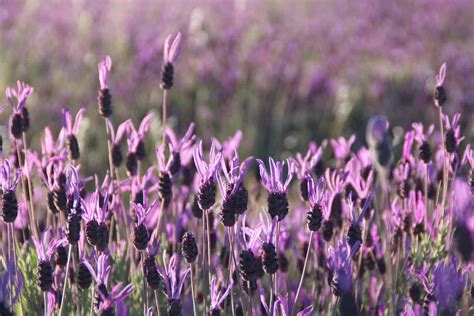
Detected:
[{"left": 193, "top": 141, "right": 222, "bottom": 210}]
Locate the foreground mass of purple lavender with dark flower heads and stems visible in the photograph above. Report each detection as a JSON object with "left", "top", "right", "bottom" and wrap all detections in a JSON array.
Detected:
[{"left": 0, "top": 34, "right": 474, "bottom": 316}]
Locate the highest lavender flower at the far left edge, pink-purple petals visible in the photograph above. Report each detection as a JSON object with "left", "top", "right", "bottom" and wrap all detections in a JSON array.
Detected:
[{"left": 5, "top": 81, "right": 33, "bottom": 139}]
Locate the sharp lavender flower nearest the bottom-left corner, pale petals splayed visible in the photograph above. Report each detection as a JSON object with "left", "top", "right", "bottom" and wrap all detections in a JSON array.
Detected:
[{"left": 32, "top": 230, "right": 65, "bottom": 292}]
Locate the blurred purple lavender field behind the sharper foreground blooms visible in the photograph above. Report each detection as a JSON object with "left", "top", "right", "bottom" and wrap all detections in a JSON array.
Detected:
[{"left": 0, "top": 0, "right": 474, "bottom": 172}]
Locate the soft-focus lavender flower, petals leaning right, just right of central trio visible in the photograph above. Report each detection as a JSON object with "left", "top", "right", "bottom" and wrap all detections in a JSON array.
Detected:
[{"left": 295, "top": 141, "right": 327, "bottom": 201}]
